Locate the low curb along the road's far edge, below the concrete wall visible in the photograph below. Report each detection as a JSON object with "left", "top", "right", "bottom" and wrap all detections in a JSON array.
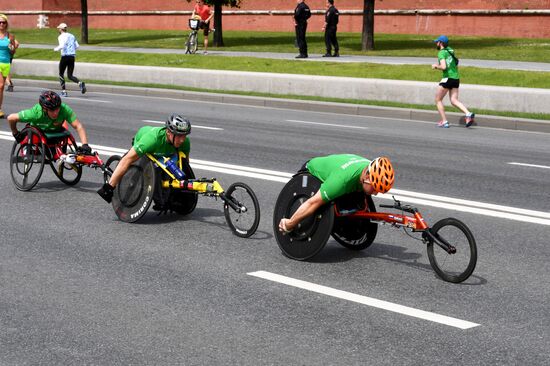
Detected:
[{"left": 12, "top": 79, "right": 550, "bottom": 133}]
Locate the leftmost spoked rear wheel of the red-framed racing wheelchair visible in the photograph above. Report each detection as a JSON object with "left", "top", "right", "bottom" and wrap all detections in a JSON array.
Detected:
[{"left": 10, "top": 128, "right": 46, "bottom": 191}]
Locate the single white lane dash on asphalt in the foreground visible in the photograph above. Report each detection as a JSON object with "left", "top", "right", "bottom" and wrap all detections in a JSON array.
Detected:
[{"left": 247, "top": 271, "right": 480, "bottom": 329}]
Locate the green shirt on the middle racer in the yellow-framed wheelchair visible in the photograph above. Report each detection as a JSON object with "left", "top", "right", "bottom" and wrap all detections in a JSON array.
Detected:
[{"left": 133, "top": 126, "right": 191, "bottom": 157}]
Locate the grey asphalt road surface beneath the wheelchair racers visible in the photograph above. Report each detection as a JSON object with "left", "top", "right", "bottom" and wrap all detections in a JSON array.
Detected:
[{"left": 0, "top": 87, "right": 550, "bottom": 365}]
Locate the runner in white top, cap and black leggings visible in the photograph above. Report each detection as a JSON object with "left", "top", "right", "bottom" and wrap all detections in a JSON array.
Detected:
[{"left": 53, "top": 23, "right": 86, "bottom": 97}]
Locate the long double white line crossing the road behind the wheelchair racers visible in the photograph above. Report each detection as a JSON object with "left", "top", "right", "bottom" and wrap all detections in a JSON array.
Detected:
[{"left": 0, "top": 131, "right": 550, "bottom": 226}]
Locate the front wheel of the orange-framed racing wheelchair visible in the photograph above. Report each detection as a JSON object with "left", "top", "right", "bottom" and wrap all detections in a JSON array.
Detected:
[{"left": 428, "top": 218, "right": 477, "bottom": 283}]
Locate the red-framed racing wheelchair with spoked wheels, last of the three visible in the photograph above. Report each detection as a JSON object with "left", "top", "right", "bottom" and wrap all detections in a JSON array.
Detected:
[{"left": 10, "top": 125, "right": 112, "bottom": 191}]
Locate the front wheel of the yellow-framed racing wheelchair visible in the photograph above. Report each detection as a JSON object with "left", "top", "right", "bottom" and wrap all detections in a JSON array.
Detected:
[{"left": 223, "top": 183, "right": 260, "bottom": 238}]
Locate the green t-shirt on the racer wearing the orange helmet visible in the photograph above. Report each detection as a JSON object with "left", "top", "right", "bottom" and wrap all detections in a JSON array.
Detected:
[{"left": 307, "top": 154, "right": 370, "bottom": 202}]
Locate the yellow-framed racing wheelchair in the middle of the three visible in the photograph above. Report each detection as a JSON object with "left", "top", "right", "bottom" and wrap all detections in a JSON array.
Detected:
[{"left": 105, "top": 152, "right": 260, "bottom": 238}]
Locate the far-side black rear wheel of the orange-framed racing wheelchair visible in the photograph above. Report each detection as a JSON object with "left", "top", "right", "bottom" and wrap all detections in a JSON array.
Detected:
[{"left": 332, "top": 193, "right": 378, "bottom": 250}]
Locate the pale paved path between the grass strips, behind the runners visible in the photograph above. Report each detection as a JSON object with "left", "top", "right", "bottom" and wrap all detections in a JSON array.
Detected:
[{"left": 20, "top": 44, "right": 550, "bottom": 72}]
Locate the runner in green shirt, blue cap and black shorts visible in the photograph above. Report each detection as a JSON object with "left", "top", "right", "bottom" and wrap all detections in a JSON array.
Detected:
[{"left": 432, "top": 35, "right": 475, "bottom": 128}]
